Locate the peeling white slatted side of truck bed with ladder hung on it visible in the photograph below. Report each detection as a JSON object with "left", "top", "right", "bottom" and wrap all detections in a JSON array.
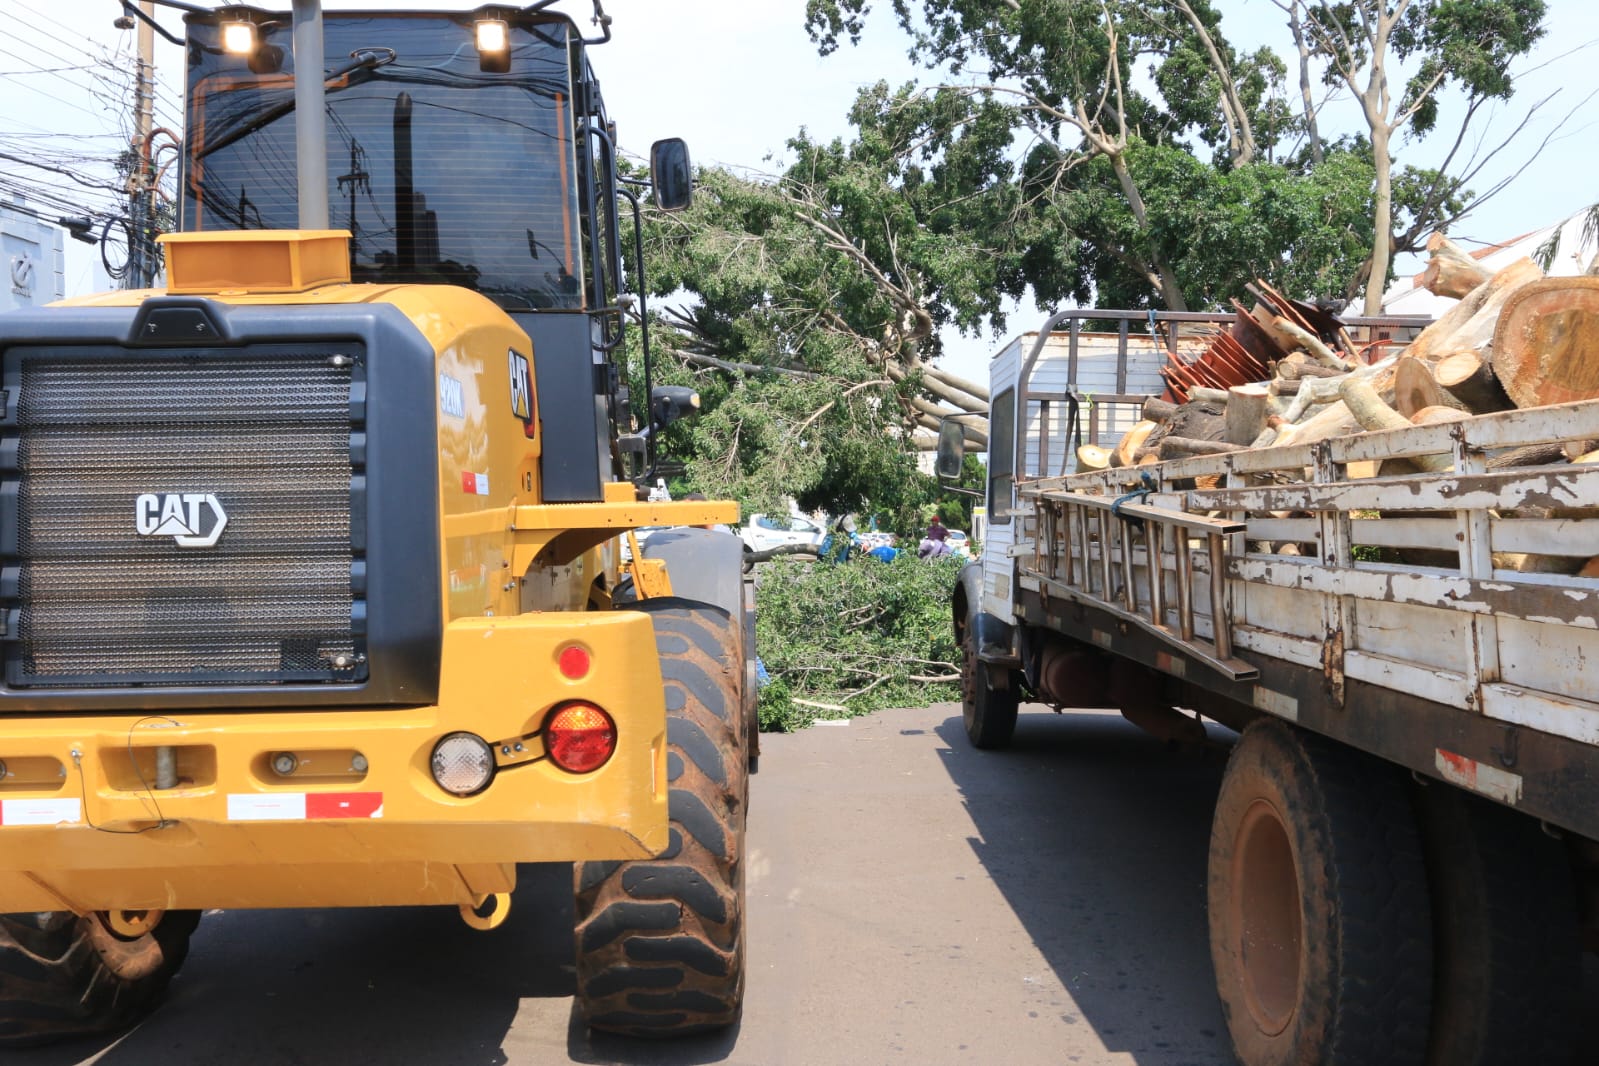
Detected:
[{"left": 1009, "top": 401, "right": 1599, "bottom": 837}]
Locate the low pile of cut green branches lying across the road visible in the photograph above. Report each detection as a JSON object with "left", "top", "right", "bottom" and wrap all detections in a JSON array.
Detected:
[{"left": 755, "top": 551, "right": 963, "bottom": 732}]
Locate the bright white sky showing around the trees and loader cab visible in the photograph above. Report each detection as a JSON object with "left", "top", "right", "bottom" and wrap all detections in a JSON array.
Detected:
[{"left": 0, "top": 0, "right": 1599, "bottom": 380}]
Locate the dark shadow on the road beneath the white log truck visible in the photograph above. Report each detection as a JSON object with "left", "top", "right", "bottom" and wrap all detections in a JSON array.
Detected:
[{"left": 937, "top": 711, "right": 1234, "bottom": 1066}]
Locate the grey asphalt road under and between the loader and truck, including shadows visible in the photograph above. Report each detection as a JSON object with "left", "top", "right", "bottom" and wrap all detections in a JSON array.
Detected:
[{"left": 15, "top": 703, "right": 1260, "bottom": 1066}]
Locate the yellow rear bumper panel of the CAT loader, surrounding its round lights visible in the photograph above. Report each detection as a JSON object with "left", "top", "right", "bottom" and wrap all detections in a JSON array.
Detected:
[{"left": 0, "top": 611, "right": 668, "bottom": 909}]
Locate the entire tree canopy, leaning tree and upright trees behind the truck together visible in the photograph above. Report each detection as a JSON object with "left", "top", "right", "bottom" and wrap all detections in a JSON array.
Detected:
[{"left": 633, "top": 0, "right": 1543, "bottom": 527}]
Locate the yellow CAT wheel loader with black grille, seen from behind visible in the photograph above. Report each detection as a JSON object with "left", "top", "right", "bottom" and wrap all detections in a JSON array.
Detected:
[{"left": 0, "top": 0, "right": 756, "bottom": 1045}]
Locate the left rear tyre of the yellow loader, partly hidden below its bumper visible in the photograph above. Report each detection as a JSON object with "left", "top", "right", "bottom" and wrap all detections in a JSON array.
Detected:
[{"left": 0, "top": 911, "right": 200, "bottom": 1047}]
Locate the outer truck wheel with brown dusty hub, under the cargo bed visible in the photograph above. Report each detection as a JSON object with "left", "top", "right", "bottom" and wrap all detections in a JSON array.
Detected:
[{"left": 1209, "top": 719, "right": 1433, "bottom": 1066}]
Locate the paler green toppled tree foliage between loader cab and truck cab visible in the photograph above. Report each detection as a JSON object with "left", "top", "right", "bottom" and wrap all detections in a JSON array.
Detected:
[{"left": 633, "top": 99, "right": 1012, "bottom": 524}]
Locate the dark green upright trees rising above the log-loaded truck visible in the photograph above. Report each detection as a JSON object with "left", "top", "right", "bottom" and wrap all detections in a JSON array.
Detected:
[{"left": 806, "top": 0, "right": 1545, "bottom": 308}]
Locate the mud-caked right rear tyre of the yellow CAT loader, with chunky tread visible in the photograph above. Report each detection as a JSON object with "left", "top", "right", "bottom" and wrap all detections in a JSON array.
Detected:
[{"left": 576, "top": 598, "right": 748, "bottom": 1036}]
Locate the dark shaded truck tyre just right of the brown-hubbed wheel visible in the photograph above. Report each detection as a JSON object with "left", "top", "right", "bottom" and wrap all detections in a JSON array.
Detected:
[{"left": 1417, "top": 783, "right": 1583, "bottom": 1066}]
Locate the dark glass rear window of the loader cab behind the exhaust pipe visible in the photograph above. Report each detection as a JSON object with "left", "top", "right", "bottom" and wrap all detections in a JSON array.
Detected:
[{"left": 181, "top": 13, "right": 584, "bottom": 310}]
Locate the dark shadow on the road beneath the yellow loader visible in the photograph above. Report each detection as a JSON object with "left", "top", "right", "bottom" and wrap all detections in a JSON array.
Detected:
[{"left": 5, "top": 865, "right": 572, "bottom": 1066}]
